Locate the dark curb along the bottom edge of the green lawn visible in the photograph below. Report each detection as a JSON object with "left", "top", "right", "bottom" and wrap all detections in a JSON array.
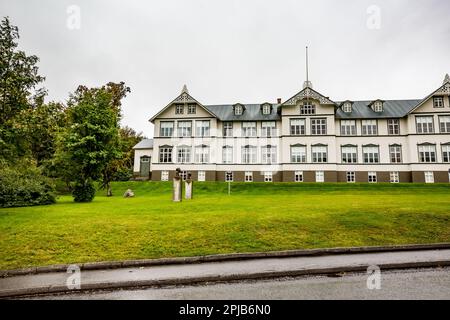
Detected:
[{"left": 0, "top": 242, "right": 450, "bottom": 278}]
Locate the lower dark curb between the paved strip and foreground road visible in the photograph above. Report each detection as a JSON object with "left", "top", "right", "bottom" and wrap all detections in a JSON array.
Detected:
[{"left": 0, "top": 260, "right": 450, "bottom": 298}]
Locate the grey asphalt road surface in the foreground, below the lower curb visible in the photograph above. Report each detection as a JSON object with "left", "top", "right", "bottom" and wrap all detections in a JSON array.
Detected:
[{"left": 24, "top": 268, "right": 450, "bottom": 300}]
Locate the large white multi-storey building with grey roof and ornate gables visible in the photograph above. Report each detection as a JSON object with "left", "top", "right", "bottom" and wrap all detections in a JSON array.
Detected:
[{"left": 134, "top": 75, "right": 450, "bottom": 183}]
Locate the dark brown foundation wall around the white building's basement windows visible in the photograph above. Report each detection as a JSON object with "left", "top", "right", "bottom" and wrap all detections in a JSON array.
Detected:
[{"left": 151, "top": 170, "right": 449, "bottom": 183}]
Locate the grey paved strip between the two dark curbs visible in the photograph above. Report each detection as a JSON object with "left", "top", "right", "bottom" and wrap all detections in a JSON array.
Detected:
[{"left": 0, "top": 249, "right": 450, "bottom": 293}]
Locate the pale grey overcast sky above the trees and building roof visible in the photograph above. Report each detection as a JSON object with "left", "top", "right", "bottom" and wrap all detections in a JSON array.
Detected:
[{"left": 0, "top": 0, "right": 450, "bottom": 137}]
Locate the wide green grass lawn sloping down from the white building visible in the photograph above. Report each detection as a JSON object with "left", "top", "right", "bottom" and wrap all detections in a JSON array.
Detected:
[{"left": 0, "top": 182, "right": 450, "bottom": 269}]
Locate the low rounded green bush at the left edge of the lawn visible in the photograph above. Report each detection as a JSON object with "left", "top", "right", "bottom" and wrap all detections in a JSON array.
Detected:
[{"left": 0, "top": 163, "right": 56, "bottom": 208}]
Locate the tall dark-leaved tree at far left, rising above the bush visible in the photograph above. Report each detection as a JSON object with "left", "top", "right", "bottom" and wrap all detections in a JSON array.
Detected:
[{"left": 0, "top": 17, "right": 46, "bottom": 161}]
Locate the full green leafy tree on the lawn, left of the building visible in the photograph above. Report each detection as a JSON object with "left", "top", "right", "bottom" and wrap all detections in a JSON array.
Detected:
[{"left": 56, "top": 82, "right": 130, "bottom": 202}]
